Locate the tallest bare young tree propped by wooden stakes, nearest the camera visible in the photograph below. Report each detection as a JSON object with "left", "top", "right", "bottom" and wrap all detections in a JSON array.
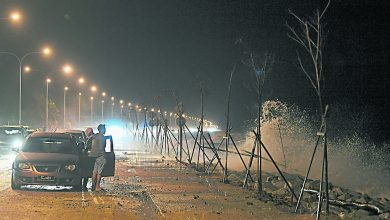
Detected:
[{"left": 286, "top": 0, "right": 330, "bottom": 219}]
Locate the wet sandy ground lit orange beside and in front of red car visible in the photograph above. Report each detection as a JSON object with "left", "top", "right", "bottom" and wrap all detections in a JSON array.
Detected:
[{"left": 0, "top": 149, "right": 331, "bottom": 220}]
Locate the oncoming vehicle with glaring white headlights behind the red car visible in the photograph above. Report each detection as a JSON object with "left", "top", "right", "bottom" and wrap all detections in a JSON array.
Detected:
[{"left": 0, "top": 125, "right": 28, "bottom": 150}]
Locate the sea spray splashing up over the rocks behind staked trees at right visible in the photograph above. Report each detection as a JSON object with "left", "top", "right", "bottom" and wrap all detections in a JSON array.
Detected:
[{"left": 240, "top": 101, "right": 390, "bottom": 198}]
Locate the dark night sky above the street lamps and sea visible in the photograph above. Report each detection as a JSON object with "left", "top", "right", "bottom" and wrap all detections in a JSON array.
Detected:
[{"left": 0, "top": 0, "right": 390, "bottom": 138}]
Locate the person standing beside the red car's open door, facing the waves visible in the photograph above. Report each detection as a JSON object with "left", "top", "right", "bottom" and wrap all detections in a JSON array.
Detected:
[{"left": 89, "top": 124, "right": 106, "bottom": 191}]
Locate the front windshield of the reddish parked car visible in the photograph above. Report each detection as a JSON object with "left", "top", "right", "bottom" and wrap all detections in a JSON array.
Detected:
[{"left": 22, "top": 137, "right": 77, "bottom": 154}]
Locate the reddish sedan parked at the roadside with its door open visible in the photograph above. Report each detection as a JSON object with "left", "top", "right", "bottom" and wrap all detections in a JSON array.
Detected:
[{"left": 11, "top": 132, "right": 115, "bottom": 190}]
